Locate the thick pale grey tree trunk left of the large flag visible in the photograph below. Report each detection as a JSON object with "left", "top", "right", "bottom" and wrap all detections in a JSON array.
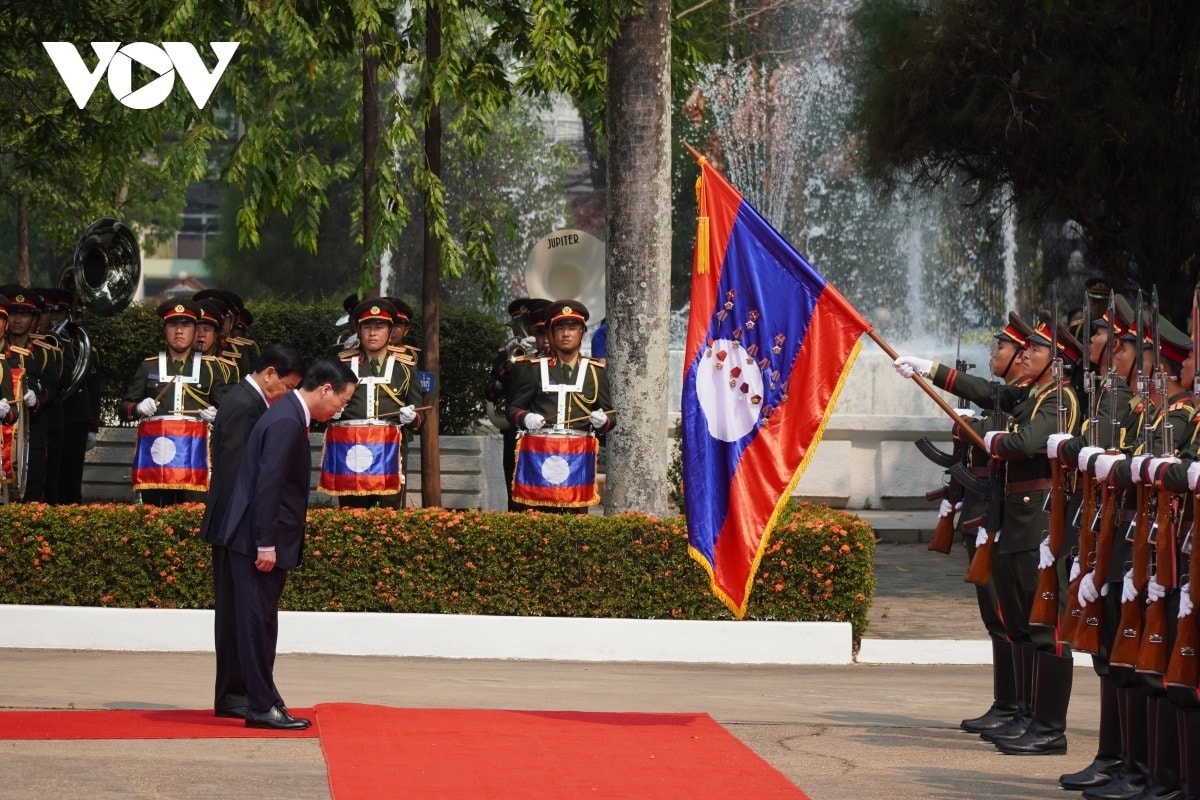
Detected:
[{"left": 595, "top": 0, "right": 671, "bottom": 516}]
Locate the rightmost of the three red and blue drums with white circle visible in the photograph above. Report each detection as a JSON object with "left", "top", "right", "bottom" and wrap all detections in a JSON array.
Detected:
[{"left": 512, "top": 428, "right": 600, "bottom": 509}]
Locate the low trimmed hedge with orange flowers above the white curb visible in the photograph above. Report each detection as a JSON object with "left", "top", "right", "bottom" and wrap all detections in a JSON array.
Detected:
[{"left": 0, "top": 503, "right": 875, "bottom": 639}]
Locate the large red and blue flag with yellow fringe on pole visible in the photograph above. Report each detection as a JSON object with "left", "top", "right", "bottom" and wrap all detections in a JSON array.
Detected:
[{"left": 682, "top": 158, "right": 871, "bottom": 619}]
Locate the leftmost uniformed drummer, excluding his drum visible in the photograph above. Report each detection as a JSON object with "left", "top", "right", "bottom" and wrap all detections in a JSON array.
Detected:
[{"left": 118, "top": 299, "right": 227, "bottom": 506}]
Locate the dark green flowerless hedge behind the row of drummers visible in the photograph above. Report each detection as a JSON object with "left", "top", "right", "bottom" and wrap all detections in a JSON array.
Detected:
[{"left": 83, "top": 300, "right": 508, "bottom": 435}]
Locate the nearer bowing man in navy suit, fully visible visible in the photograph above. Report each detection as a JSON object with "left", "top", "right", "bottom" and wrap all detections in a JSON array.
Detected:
[{"left": 218, "top": 357, "right": 358, "bottom": 730}]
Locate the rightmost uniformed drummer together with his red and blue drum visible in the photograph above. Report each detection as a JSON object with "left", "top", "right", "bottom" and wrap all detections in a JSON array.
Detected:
[{"left": 506, "top": 300, "right": 617, "bottom": 513}]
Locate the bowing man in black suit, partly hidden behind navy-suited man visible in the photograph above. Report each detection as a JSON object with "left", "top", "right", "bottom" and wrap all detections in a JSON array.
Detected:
[{"left": 200, "top": 344, "right": 304, "bottom": 717}]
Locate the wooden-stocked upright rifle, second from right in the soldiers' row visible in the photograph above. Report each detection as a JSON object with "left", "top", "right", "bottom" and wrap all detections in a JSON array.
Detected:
[{"left": 1136, "top": 287, "right": 1177, "bottom": 675}]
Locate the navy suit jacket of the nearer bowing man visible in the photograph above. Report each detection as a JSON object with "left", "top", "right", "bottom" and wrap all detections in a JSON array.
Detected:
[{"left": 217, "top": 392, "right": 312, "bottom": 570}]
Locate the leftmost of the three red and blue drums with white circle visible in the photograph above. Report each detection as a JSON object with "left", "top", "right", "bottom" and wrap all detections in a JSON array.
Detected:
[{"left": 133, "top": 414, "right": 210, "bottom": 492}]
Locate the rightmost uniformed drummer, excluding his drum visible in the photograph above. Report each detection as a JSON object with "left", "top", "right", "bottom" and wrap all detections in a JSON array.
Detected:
[{"left": 506, "top": 300, "right": 617, "bottom": 513}]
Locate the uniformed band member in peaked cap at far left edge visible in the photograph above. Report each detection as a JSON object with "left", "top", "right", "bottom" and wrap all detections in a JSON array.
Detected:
[{"left": 0, "top": 284, "right": 62, "bottom": 503}]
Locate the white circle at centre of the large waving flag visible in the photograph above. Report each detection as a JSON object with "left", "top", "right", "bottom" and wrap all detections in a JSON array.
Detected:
[{"left": 695, "top": 339, "right": 763, "bottom": 441}]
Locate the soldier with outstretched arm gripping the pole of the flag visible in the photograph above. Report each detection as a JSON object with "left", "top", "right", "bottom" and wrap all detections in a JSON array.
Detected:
[{"left": 895, "top": 315, "right": 1082, "bottom": 756}]
